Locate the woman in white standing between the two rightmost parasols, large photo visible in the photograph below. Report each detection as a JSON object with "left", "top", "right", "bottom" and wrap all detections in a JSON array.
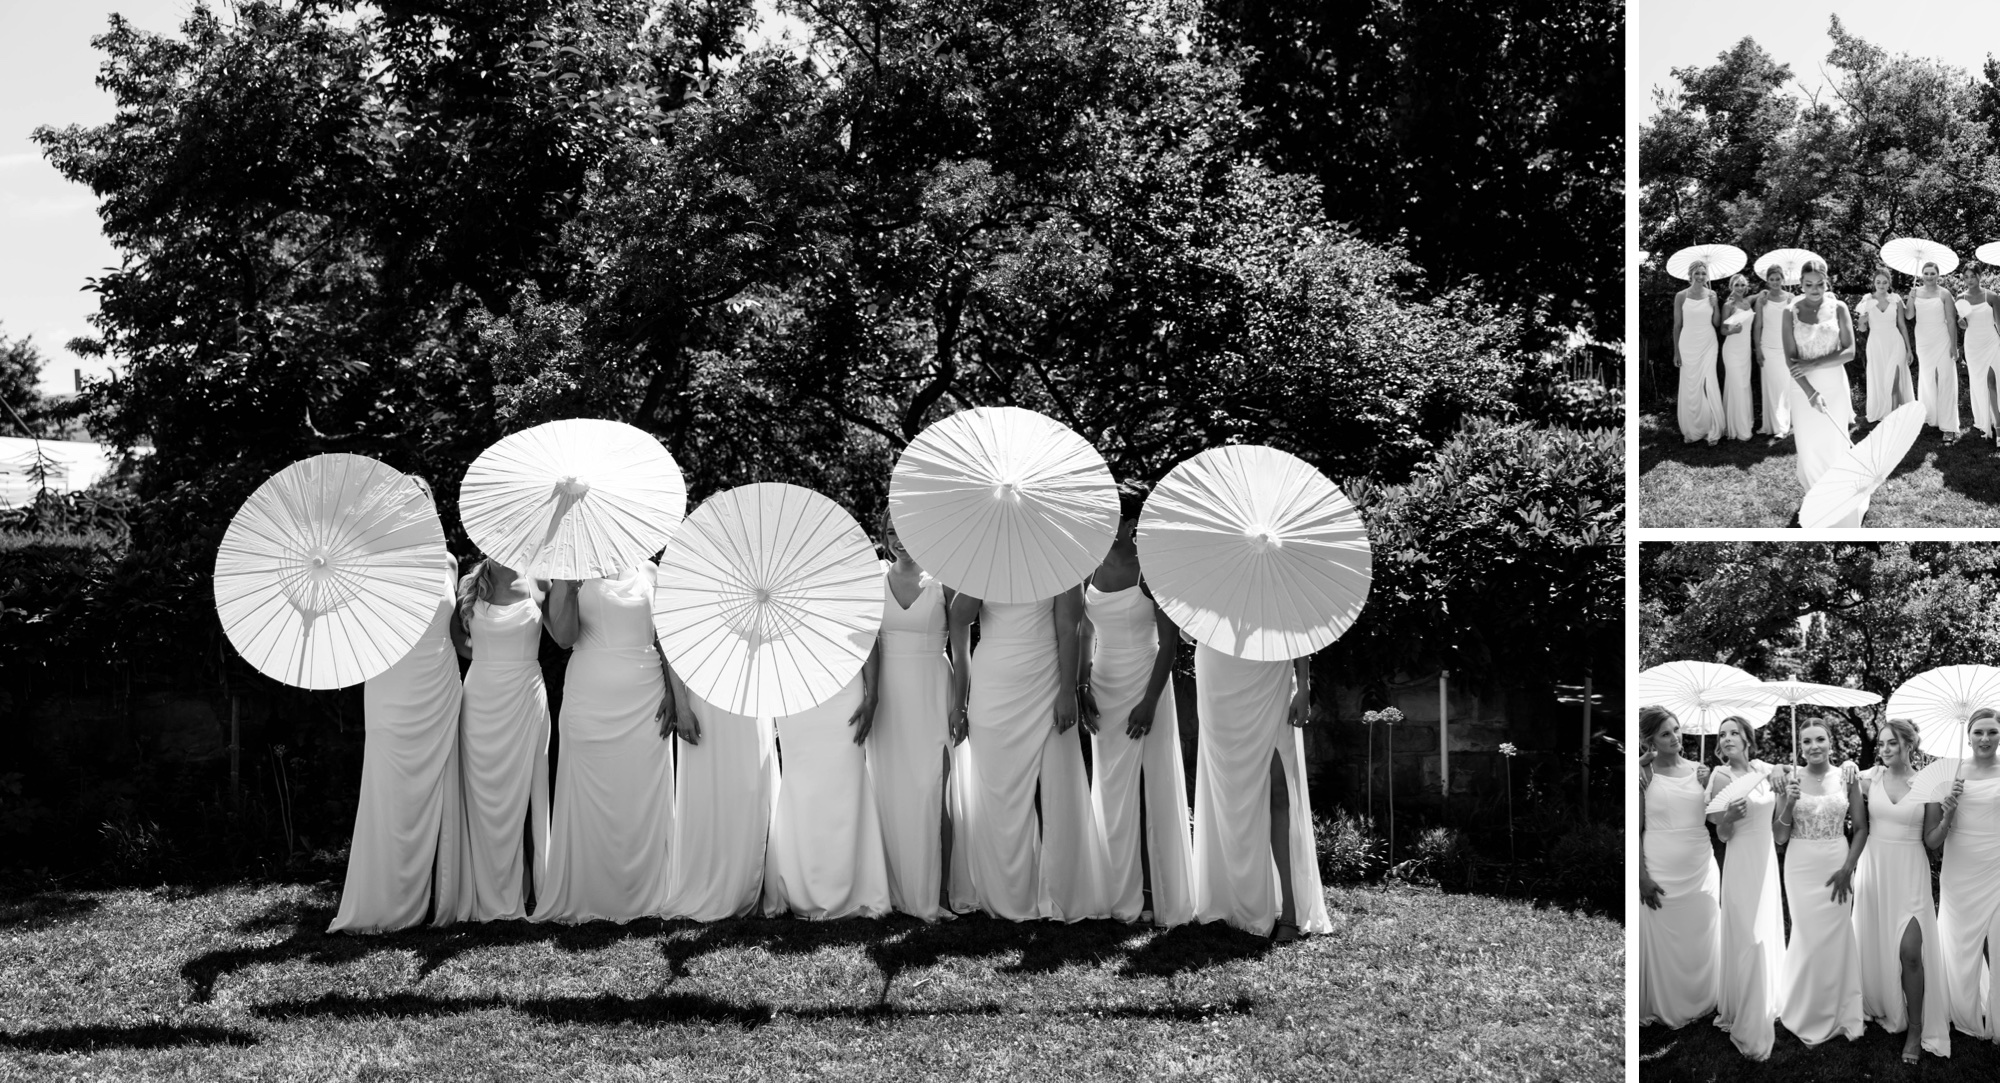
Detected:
[{"left": 1076, "top": 494, "right": 1194, "bottom": 927}]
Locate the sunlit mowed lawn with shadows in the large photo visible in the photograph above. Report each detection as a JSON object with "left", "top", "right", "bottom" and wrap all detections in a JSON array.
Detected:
[{"left": 0, "top": 885, "right": 1624, "bottom": 1081}]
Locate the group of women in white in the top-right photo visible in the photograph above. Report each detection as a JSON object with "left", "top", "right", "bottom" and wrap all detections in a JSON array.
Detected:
[{"left": 1674, "top": 260, "right": 2000, "bottom": 490}]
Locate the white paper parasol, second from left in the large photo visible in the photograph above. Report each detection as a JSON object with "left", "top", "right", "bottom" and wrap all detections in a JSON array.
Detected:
[{"left": 458, "top": 418, "right": 688, "bottom": 579}]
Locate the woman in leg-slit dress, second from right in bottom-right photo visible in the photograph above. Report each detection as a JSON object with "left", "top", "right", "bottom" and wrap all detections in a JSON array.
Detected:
[{"left": 1854, "top": 717, "right": 1952, "bottom": 1065}]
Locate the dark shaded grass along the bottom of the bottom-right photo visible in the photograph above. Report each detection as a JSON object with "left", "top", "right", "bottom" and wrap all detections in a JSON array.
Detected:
[{"left": 1638, "top": 1015, "right": 2000, "bottom": 1083}]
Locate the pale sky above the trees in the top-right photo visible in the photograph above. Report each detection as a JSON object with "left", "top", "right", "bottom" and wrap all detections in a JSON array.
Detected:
[{"left": 1626, "top": 0, "right": 2000, "bottom": 115}]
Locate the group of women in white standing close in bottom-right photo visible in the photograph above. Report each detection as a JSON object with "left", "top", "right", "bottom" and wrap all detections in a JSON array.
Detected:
[{"left": 1640, "top": 707, "right": 2000, "bottom": 1063}]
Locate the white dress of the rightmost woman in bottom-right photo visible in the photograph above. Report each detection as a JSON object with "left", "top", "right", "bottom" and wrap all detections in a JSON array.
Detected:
[{"left": 1924, "top": 779, "right": 2000, "bottom": 1039}]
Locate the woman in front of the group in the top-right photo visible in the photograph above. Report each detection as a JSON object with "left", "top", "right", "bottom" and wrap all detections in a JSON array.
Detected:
[{"left": 1784, "top": 260, "right": 1860, "bottom": 526}]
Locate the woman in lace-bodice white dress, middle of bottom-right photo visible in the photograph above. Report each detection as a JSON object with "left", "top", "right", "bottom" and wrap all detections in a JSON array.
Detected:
[{"left": 1776, "top": 721, "right": 1868, "bottom": 1045}]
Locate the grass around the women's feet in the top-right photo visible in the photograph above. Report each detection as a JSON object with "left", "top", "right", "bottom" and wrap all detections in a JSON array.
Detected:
[{"left": 1638, "top": 366, "right": 2000, "bottom": 528}]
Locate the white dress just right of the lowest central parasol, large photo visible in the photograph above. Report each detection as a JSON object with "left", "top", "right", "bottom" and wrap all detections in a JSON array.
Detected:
[{"left": 868, "top": 561, "right": 952, "bottom": 921}]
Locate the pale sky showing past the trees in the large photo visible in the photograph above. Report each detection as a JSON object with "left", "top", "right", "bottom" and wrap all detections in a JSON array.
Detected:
[{"left": 0, "top": 0, "right": 802, "bottom": 392}]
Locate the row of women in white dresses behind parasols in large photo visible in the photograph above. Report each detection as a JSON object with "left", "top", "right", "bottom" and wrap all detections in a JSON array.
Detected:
[{"left": 332, "top": 489, "right": 1330, "bottom": 939}]
